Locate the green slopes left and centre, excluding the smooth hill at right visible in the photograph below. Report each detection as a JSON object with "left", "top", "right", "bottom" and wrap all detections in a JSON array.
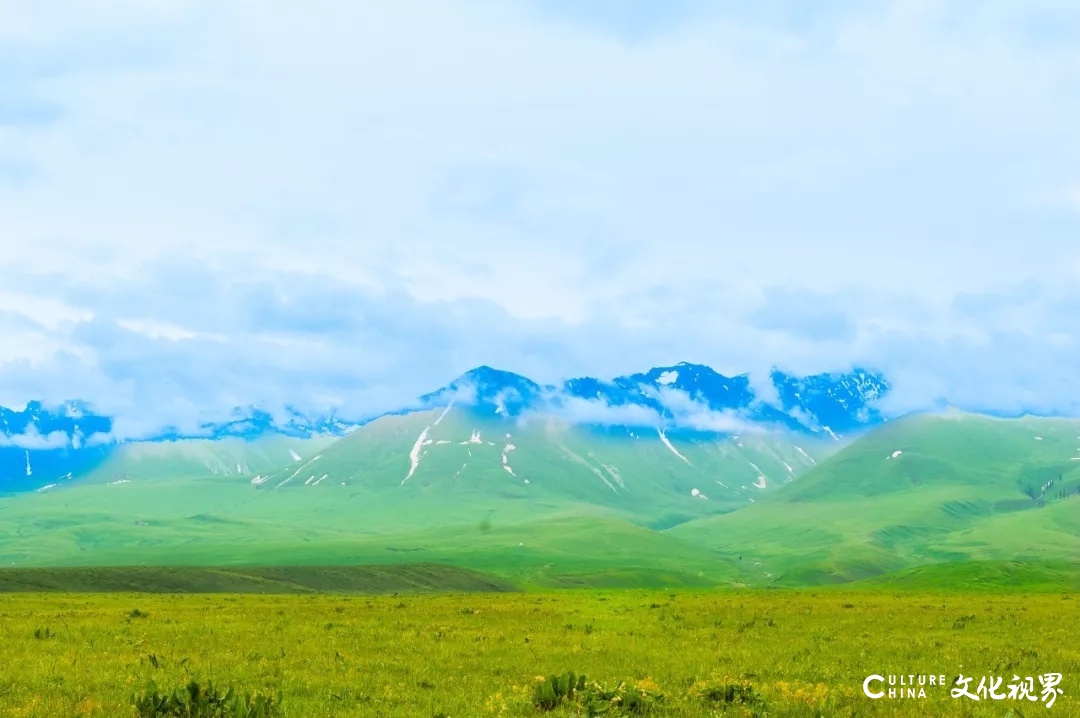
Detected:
[{"left": 0, "top": 409, "right": 836, "bottom": 585}]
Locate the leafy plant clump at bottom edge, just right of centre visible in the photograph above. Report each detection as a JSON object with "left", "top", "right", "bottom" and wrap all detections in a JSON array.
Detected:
[{"left": 532, "top": 670, "right": 664, "bottom": 716}]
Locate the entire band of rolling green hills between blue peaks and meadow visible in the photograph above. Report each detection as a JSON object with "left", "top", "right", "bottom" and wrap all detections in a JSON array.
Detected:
[{"left": 8, "top": 408, "right": 1080, "bottom": 586}]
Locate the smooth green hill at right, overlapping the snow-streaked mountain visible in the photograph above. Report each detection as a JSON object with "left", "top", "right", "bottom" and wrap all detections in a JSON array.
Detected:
[{"left": 672, "top": 414, "right": 1080, "bottom": 583}]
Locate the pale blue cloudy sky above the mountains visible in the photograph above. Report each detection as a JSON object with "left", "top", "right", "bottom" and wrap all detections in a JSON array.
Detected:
[{"left": 0, "top": 0, "right": 1080, "bottom": 433}]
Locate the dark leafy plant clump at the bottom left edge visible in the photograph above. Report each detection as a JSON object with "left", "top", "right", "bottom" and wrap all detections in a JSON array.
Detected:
[{"left": 133, "top": 680, "right": 281, "bottom": 718}]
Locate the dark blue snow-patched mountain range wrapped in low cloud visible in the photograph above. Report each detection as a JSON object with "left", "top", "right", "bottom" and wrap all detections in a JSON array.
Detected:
[{"left": 0, "top": 362, "right": 890, "bottom": 491}]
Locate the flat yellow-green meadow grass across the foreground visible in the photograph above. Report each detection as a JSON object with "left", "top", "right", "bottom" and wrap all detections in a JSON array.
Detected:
[{"left": 0, "top": 591, "right": 1080, "bottom": 718}]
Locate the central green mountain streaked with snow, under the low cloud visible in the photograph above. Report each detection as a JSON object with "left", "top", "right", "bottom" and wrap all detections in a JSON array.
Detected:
[{"left": 252, "top": 408, "right": 836, "bottom": 528}]
